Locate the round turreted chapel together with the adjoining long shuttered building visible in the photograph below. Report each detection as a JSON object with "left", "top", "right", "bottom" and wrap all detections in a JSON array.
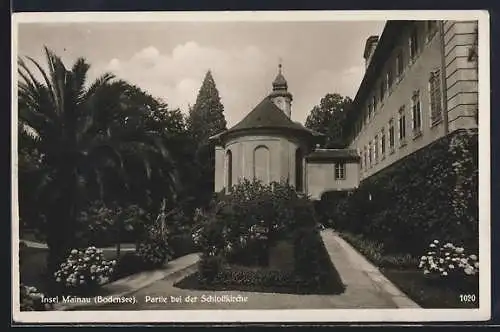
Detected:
[{"left": 211, "top": 21, "right": 478, "bottom": 199}]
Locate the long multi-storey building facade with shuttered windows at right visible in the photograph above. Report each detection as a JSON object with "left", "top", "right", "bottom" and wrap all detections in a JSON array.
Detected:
[{"left": 348, "top": 21, "right": 478, "bottom": 179}]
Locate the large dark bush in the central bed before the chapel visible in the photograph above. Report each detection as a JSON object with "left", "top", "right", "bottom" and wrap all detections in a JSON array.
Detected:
[{"left": 194, "top": 180, "right": 339, "bottom": 294}]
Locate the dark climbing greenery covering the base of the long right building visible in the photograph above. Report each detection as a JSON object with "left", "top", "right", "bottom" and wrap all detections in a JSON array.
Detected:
[{"left": 320, "top": 130, "right": 479, "bottom": 255}]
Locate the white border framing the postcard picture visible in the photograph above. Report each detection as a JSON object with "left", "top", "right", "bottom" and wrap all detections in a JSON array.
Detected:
[{"left": 11, "top": 10, "right": 491, "bottom": 323}]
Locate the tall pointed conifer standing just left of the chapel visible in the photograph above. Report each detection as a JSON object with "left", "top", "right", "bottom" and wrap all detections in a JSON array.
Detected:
[{"left": 188, "top": 70, "right": 227, "bottom": 205}]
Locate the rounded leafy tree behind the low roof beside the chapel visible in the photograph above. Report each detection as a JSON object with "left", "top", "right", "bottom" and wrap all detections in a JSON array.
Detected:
[{"left": 305, "top": 93, "right": 352, "bottom": 148}]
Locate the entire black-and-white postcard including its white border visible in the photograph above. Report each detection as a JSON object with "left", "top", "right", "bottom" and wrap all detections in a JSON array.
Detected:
[{"left": 12, "top": 11, "right": 491, "bottom": 323}]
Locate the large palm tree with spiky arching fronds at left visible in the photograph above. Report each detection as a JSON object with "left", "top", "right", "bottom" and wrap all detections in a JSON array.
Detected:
[{"left": 18, "top": 48, "right": 176, "bottom": 272}]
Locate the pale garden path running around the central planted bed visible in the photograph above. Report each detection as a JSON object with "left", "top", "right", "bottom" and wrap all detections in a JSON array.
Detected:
[{"left": 67, "top": 230, "right": 419, "bottom": 310}]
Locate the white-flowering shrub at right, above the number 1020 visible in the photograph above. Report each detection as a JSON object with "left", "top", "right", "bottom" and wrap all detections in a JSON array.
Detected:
[{"left": 418, "top": 240, "right": 479, "bottom": 277}]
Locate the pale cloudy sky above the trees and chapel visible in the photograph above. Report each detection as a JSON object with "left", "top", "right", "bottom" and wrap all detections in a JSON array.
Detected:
[{"left": 17, "top": 21, "right": 385, "bottom": 126}]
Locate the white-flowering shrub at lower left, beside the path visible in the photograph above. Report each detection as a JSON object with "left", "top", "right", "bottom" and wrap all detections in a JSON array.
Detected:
[{"left": 54, "top": 247, "right": 116, "bottom": 290}]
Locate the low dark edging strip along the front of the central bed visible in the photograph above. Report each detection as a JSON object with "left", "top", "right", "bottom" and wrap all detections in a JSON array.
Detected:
[{"left": 174, "top": 265, "right": 344, "bottom": 295}]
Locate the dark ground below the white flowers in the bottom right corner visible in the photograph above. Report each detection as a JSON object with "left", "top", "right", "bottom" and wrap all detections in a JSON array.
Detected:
[{"left": 381, "top": 268, "right": 479, "bottom": 309}]
